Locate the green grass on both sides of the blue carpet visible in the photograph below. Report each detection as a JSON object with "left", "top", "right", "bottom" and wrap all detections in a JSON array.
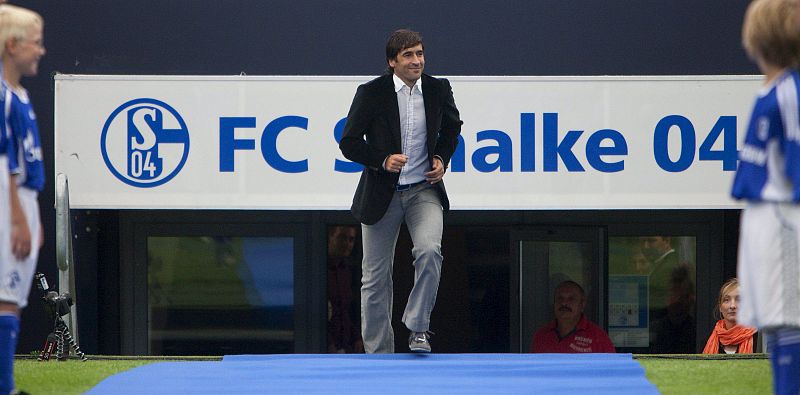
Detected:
[{"left": 14, "top": 355, "right": 772, "bottom": 395}]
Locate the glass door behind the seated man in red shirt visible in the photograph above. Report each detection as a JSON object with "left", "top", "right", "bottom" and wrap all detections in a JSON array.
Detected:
[{"left": 510, "top": 226, "right": 606, "bottom": 353}]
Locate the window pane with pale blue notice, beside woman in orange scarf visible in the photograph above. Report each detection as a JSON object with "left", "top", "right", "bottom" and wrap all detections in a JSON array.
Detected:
[{"left": 608, "top": 236, "right": 697, "bottom": 354}]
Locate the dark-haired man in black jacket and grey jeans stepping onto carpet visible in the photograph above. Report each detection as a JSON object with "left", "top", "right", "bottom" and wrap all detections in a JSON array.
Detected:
[{"left": 339, "top": 30, "right": 462, "bottom": 353}]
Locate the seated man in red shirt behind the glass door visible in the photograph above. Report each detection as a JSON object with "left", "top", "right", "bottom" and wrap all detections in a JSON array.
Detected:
[{"left": 531, "top": 280, "right": 616, "bottom": 353}]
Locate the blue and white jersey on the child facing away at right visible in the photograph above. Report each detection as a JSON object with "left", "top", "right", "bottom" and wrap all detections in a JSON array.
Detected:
[{"left": 731, "top": 70, "right": 800, "bottom": 203}]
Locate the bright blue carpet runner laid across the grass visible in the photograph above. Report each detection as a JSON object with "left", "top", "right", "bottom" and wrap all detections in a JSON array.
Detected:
[{"left": 87, "top": 354, "right": 658, "bottom": 395}]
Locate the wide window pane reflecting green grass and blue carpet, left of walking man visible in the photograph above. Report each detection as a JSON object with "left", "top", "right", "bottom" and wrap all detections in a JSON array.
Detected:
[{"left": 147, "top": 237, "right": 294, "bottom": 355}]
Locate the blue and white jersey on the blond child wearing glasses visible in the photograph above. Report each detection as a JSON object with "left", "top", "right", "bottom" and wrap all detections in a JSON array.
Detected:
[{"left": 3, "top": 86, "right": 45, "bottom": 192}]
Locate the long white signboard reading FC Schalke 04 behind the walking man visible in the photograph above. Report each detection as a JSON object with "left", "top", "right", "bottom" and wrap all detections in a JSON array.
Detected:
[{"left": 55, "top": 75, "right": 761, "bottom": 210}]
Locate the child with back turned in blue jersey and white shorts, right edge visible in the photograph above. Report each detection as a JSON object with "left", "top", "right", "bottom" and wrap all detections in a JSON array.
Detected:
[{"left": 732, "top": 0, "right": 800, "bottom": 395}]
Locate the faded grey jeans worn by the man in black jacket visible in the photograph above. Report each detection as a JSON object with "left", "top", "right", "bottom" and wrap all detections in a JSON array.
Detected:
[{"left": 361, "top": 183, "right": 443, "bottom": 353}]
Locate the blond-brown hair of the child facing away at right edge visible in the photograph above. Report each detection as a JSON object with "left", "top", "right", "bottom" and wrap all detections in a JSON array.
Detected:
[{"left": 742, "top": 0, "right": 800, "bottom": 67}]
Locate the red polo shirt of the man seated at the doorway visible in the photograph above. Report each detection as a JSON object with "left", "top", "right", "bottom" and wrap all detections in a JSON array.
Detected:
[{"left": 531, "top": 315, "right": 616, "bottom": 353}]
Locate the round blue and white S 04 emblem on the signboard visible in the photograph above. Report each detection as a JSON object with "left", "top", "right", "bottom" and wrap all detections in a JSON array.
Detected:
[{"left": 100, "top": 98, "right": 189, "bottom": 188}]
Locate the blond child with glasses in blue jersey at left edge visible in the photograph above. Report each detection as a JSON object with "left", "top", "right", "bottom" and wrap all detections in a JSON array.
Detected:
[{"left": 0, "top": 4, "right": 45, "bottom": 394}]
